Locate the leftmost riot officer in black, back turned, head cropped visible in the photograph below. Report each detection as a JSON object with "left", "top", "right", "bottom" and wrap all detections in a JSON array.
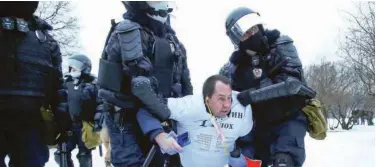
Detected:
[{"left": 0, "top": 1, "right": 70, "bottom": 167}]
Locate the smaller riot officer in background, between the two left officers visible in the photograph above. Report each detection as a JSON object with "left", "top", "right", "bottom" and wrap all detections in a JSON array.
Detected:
[{"left": 55, "top": 54, "right": 100, "bottom": 167}]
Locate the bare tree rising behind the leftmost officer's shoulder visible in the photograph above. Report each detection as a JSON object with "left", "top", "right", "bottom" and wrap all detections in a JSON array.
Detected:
[{"left": 35, "top": 1, "right": 81, "bottom": 56}]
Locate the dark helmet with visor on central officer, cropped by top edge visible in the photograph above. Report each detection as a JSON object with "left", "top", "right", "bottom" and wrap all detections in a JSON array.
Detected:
[{"left": 122, "top": 1, "right": 173, "bottom": 23}]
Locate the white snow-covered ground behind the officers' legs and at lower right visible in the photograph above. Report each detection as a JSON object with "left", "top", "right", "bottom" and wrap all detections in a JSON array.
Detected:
[{"left": 3, "top": 125, "right": 375, "bottom": 167}]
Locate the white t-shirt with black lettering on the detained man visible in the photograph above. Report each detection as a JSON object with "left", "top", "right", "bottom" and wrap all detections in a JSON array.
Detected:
[{"left": 168, "top": 91, "right": 253, "bottom": 167}]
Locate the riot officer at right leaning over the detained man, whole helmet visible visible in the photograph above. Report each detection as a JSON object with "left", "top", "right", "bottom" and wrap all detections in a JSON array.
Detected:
[{"left": 220, "top": 7, "right": 312, "bottom": 167}]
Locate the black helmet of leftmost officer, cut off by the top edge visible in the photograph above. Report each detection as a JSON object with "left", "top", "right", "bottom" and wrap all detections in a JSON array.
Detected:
[{"left": 0, "top": 1, "right": 39, "bottom": 18}]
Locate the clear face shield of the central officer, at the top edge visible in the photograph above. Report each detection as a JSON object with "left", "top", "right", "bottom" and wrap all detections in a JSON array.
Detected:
[{"left": 146, "top": 1, "right": 176, "bottom": 23}]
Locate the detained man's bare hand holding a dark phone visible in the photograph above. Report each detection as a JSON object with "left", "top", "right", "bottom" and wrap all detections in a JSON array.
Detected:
[{"left": 155, "top": 132, "right": 183, "bottom": 155}]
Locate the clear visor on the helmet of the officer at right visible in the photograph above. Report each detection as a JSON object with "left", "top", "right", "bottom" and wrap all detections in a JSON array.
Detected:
[{"left": 227, "top": 13, "right": 263, "bottom": 45}]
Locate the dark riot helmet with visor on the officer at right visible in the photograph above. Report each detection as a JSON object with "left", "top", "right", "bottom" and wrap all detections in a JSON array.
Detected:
[{"left": 225, "top": 7, "right": 263, "bottom": 46}]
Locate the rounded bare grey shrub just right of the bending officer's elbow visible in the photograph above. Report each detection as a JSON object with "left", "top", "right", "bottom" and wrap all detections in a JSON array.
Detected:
[{"left": 306, "top": 61, "right": 370, "bottom": 130}]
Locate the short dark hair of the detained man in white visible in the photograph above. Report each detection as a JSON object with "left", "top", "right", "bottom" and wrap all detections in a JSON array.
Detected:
[{"left": 202, "top": 74, "right": 231, "bottom": 98}]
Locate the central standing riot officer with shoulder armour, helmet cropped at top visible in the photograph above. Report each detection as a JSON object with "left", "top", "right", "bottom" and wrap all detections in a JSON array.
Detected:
[{"left": 98, "top": 1, "right": 192, "bottom": 166}]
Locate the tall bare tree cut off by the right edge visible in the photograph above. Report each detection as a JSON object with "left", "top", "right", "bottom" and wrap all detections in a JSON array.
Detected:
[{"left": 340, "top": 1, "right": 375, "bottom": 98}]
